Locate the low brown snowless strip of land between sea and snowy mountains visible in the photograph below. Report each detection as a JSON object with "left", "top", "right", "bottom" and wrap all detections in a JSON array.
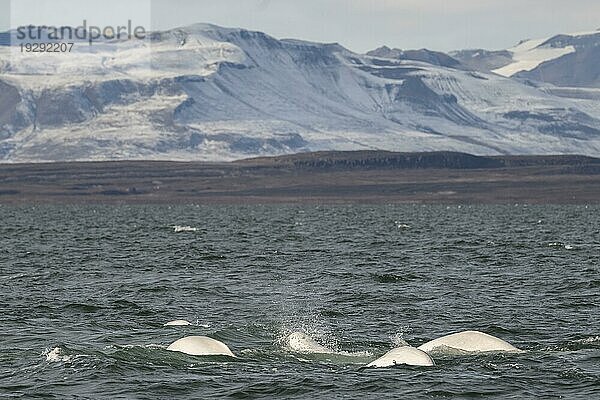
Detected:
[{"left": 0, "top": 151, "right": 600, "bottom": 205}]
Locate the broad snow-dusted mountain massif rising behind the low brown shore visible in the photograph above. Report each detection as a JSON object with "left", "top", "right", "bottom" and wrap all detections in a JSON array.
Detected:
[{"left": 0, "top": 24, "right": 600, "bottom": 162}]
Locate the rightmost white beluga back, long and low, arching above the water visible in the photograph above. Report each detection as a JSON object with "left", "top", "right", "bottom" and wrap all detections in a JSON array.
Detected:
[{"left": 418, "top": 331, "right": 521, "bottom": 353}]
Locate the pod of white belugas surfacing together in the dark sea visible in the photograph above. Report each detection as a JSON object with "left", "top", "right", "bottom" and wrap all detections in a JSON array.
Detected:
[{"left": 162, "top": 321, "right": 522, "bottom": 368}]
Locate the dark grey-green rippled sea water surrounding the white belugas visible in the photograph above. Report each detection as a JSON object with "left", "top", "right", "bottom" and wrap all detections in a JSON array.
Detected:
[{"left": 0, "top": 205, "right": 600, "bottom": 399}]
